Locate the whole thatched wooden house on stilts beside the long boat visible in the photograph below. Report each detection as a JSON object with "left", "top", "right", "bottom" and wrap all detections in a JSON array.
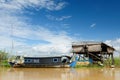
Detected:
[{"left": 72, "top": 41, "right": 115, "bottom": 66}]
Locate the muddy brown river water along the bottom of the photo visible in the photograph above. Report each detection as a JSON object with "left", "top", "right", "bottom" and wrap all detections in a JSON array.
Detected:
[{"left": 0, "top": 67, "right": 120, "bottom": 80}]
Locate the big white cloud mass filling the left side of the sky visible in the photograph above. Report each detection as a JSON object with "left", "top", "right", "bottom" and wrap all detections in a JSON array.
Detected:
[{"left": 0, "top": 0, "right": 73, "bottom": 55}]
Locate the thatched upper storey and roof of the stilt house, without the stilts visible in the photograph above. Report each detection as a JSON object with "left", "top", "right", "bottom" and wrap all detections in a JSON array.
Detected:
[{"left": 72, "top": 41, "right": 115, "bottom": 53}]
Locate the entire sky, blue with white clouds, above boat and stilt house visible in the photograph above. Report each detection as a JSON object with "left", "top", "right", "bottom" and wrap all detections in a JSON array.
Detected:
[{"left": 0, "top": 0, "right": 120, "bottom": 56}]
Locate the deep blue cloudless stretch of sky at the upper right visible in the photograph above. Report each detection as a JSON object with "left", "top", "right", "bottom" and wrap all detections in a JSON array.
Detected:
[{"left": 21, "top": 0, "right": 120, "bottom": 41}]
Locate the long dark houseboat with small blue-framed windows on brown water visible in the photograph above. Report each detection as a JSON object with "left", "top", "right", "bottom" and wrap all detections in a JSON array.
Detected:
[{"left": 9, "top": 56, "right": 71, "bottom": 68}]
